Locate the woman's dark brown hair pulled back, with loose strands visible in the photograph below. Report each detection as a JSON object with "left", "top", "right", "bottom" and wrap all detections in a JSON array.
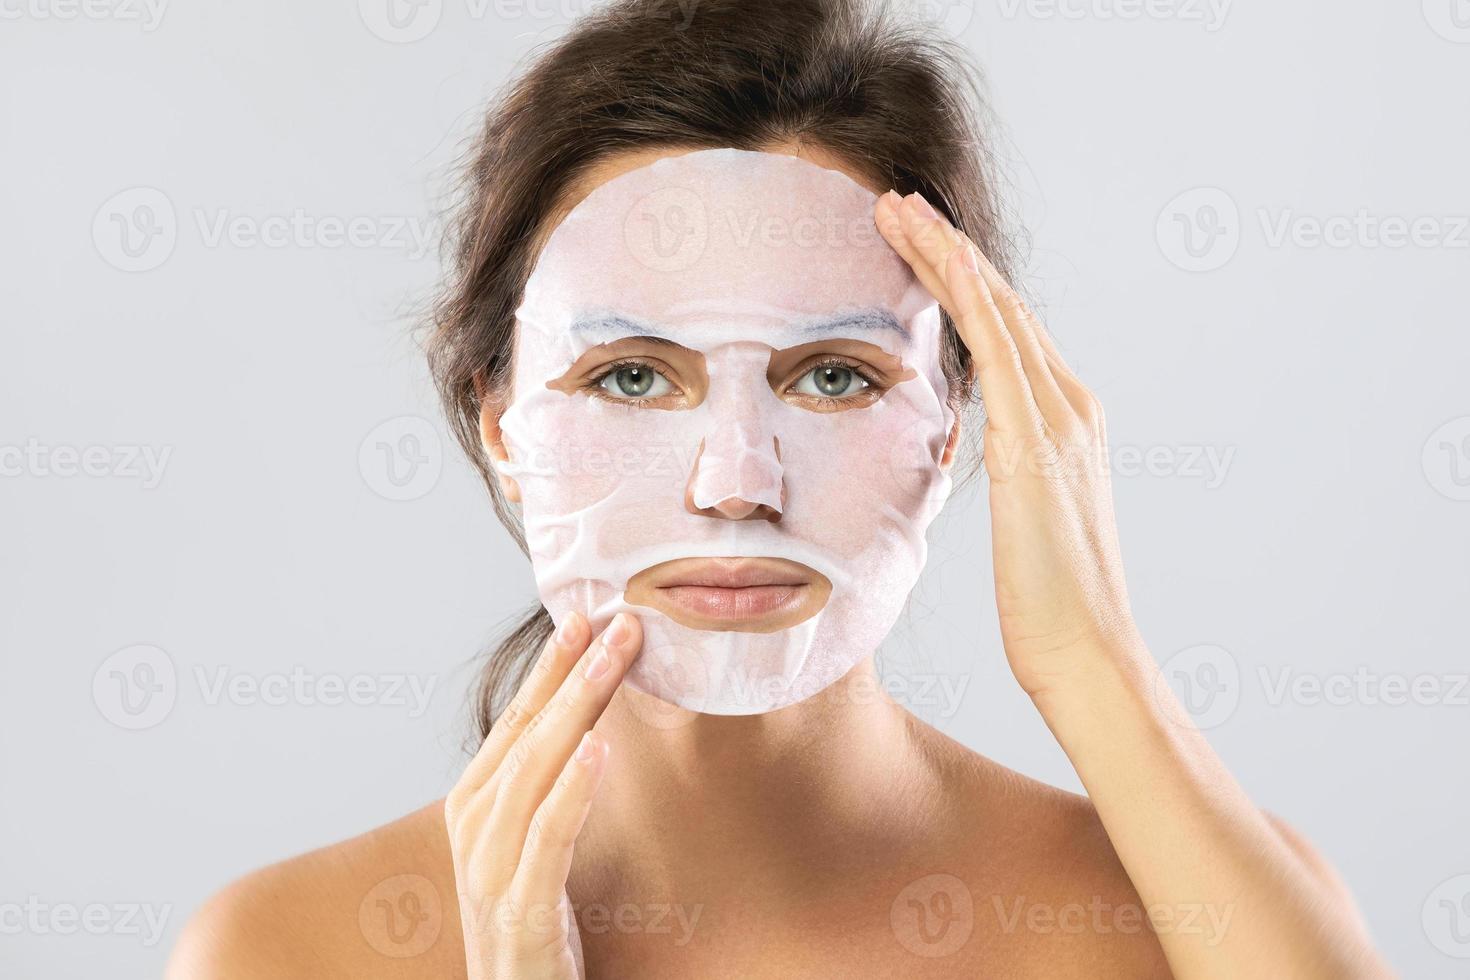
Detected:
[{"left": 428, "top": 0, "right": 1011, "bottom": 738}]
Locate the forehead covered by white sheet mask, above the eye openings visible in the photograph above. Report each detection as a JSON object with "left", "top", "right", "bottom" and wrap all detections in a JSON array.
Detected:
[{"left": 522, "top": 150, "right": 932, "bottom": 347}]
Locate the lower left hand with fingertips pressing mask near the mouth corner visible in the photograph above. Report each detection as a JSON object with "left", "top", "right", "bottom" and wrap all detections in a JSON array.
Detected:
[{"left": 444, "top": 613, "right": 642, "bottom": 980}]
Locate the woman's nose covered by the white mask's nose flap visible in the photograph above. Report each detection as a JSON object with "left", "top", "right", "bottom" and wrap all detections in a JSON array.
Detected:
[{"left": 684, "top": 425, "right": 786, "bottom": 523}]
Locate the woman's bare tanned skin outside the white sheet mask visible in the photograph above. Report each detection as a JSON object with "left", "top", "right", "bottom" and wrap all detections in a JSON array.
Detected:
[{"left": 168, "top": 147, "right": 1391, "bottom": 980}]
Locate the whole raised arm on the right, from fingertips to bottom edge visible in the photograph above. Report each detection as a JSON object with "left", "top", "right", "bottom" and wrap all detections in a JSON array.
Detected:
[{"left": 875, "top": 192, "right": 1392, "bottom": 980}]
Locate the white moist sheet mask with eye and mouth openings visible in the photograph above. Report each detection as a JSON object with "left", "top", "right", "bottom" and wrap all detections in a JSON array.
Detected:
[{"left": 500, "top": 150, "right": 954, "bottom": 714}]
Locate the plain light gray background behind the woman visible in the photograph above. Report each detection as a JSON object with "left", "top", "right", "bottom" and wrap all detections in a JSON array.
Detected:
[{"left": 0, "top": 0, "right": 1470, "bottom": 977}]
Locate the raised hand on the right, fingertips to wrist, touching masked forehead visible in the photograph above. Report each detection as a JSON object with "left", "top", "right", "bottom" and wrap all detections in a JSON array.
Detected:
[{"left": 875, "top": 191, "right": 1142, "bottom": 698}]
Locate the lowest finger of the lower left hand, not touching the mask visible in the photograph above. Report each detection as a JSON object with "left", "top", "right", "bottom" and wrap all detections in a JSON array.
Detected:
[{"left": 510, "top": 732, "right": 607, "bottom": 908}]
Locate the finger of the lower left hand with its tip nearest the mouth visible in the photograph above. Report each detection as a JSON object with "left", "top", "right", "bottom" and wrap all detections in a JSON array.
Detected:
[{"left": 472, "top": 613, "right": 642, "bottom": 893}]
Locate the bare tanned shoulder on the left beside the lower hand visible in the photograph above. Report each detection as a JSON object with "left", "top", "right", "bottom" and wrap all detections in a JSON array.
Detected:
[{"left": 166, "top": 804, "right": 465, "bottom": 980}]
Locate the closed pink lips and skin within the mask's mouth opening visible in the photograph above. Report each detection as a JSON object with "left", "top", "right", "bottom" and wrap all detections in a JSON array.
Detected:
[{"left": 626, "top": 558, "right": 832, "bottom": 633}]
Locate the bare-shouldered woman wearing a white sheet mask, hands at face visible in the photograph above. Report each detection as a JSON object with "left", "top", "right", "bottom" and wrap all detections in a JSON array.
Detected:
[{"left": 171, "top": 0, "right": 1388, "bottom": 979}]
